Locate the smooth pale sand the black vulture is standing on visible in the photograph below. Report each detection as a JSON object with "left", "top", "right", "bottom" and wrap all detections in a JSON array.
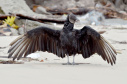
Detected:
[{"left": 0, "top": 29, "right": 127, "bottom": 84}]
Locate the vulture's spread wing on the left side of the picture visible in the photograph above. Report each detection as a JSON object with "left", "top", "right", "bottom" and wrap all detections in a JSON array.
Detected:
[{"left": 8, "top": 27, "right": 65, "bottom": 60}]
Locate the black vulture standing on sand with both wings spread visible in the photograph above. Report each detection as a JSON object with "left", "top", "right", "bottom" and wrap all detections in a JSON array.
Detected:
[{"left": 8, "top": 14, "right": 117, "bottom": 65}]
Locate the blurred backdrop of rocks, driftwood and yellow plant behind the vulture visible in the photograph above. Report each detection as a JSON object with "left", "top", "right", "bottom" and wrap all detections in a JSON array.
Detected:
[{"left": 0, "top": 0, "right": 127, "bottom": 36}]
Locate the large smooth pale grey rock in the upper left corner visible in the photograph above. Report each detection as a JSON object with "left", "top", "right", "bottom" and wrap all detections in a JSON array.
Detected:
[{"left": 0, "top": 0, "right": 46, "bottom": 17}]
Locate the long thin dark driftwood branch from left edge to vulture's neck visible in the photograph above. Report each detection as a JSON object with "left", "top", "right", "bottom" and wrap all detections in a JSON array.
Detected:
[{"left": 0, "top": 14, "right": 65, "bottom": 24}]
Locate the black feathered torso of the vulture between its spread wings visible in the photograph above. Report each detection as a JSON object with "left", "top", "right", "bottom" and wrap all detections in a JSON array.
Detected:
[{"left": 60, "top": 22, "right": 77, "bottom": 56}]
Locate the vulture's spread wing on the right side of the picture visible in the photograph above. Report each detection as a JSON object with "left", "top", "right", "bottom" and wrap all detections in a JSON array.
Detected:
[{"left": 78, "top": 26, "right": 117, "bottom": 65}]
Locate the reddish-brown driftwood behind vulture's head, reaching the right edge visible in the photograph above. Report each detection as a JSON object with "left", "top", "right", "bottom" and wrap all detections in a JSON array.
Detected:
[{"left": 46, "top": 7, "right": 127, "bottom": 20}]
